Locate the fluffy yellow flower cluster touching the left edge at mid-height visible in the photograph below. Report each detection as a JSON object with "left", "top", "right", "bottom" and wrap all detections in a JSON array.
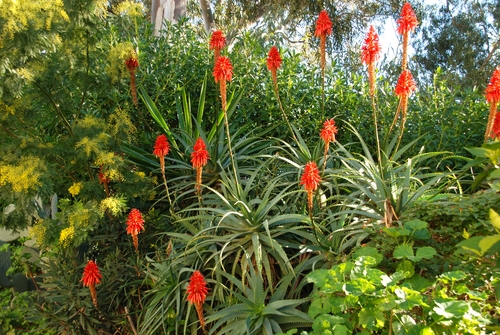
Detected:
[{"left": 0, "top": 156, "right": 46, "bottom": 193}]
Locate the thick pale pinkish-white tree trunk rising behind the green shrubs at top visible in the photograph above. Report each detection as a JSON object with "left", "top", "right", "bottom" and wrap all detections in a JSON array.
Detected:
[{"left": 151, "top": 0, "right": 187, "bottom": 36}]
